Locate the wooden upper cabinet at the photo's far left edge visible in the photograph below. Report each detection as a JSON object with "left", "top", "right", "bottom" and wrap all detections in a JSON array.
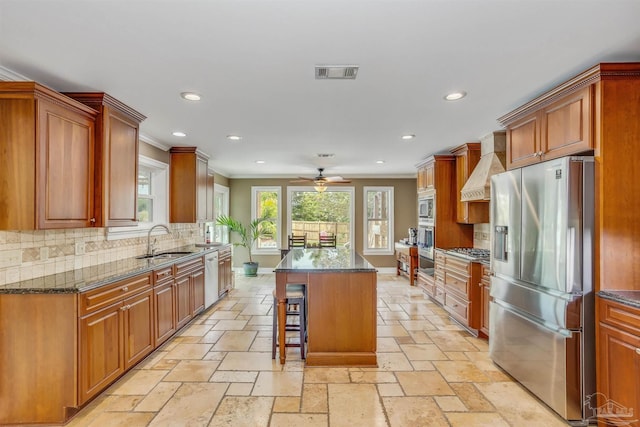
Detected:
[{"left": 0, "top": 82, "right": 96, "bottom": 230}]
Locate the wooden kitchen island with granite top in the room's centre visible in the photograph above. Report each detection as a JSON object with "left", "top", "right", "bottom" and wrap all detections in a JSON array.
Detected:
[{"left": 275, "top": 248, "right": 377, "bottom": 367}]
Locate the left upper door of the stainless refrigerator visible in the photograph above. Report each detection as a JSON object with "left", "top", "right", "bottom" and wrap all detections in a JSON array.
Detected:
[{"left": 491, "top": 169, "right": 521, "bottom": 279}]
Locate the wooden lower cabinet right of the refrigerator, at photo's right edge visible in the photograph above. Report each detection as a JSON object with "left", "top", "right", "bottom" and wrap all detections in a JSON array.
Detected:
[{"left": 596, "top": 298, "right": 640, "bottom": 427}]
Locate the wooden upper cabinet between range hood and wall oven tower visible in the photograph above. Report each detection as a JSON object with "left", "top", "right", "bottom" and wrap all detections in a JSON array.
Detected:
[{"left": 451, "top": 142, "right": 489, "bottom": 224}]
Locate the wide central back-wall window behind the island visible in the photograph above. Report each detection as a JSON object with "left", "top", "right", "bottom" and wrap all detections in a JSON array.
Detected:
[{"left": 287, "top": 187, "right": 354, "bottom": 248}]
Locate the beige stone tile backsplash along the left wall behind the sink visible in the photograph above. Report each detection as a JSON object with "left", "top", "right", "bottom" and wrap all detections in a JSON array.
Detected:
[{"left": 0, "top": 224, "right": 202, "bottom": 286}]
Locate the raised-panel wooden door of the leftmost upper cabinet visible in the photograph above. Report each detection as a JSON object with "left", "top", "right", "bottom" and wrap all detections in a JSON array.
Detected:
[{"left": 36, "top": 100, "right": 95, "bottom": 229}]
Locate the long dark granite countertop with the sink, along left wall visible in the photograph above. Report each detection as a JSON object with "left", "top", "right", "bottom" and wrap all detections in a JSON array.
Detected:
[{"left": 0, "top": 245, "right": 228, "bottom": 294}]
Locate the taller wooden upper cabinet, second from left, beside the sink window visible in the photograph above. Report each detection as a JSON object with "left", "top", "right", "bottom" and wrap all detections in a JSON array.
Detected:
[{"left": 65, "top": 92, "right": 146, "bottom": 227}]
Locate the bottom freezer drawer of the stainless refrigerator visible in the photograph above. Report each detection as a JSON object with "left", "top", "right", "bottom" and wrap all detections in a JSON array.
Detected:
[{"left": 489, "top": 301, "right": 585, "bottom": 422}]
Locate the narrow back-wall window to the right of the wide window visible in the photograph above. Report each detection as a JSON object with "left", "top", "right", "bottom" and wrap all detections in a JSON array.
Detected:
[{"left": 363, "top": 187, "right": 394, "bottom": 255}]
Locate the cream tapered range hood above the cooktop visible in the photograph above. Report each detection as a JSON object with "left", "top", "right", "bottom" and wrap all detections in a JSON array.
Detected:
[{"left": 460, "top": 131, "right": 507, "bottom": 202}]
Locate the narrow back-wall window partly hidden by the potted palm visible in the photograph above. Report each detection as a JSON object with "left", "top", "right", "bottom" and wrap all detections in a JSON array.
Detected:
[{"left": 251, "top": 187, "right": 281, "bottom": 254}]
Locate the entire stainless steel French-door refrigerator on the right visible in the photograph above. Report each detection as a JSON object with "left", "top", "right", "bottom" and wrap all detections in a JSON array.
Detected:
[{"left": 489, "top": 157, "right": 595, "bottom": 425}]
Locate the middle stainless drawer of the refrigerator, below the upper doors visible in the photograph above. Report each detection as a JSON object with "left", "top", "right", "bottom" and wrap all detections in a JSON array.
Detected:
[{"left": 491, "top": 277, "right": 583, "bottom": 334}]
